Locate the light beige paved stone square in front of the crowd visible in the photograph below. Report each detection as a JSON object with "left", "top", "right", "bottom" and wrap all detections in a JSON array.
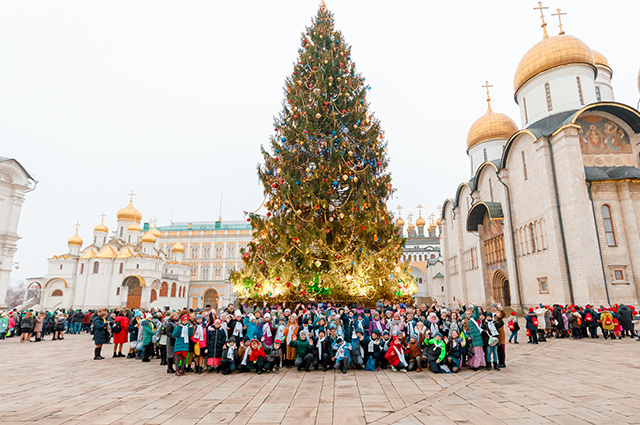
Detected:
[{"left": 0, "top": 332, "right": 640, "bottom": 425}]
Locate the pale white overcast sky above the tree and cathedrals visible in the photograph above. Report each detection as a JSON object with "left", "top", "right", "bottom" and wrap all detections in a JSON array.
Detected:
[{"left": 0, "top": 0, "right": 640, "bottom": 279}]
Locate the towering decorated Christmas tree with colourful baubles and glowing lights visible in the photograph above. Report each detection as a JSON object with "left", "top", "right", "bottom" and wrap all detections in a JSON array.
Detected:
[{"left": 231, "top": 4, "right": 415, "bottom": 302}]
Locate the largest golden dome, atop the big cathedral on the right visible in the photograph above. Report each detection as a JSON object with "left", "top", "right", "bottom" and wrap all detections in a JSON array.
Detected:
[{"left": 513, "top": 34, "right": 596, "bottom": 93}]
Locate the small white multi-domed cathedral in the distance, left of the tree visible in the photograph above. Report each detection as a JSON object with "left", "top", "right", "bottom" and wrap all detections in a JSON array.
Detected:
[{"left": 27, "top": 197, "right": 191, "bottom": 310}]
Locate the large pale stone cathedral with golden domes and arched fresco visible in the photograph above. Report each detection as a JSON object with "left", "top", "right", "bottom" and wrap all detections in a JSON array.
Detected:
[{"left": 442, "top": 11, "right": 640, "bottom": 309}]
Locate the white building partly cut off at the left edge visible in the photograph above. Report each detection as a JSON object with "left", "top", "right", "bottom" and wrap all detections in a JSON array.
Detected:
[{"left": 0, "top": 156, "right": 37, "bottom": 308}]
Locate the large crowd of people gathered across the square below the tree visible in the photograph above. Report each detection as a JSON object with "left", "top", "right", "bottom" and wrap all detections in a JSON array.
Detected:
[{"left": 0, "top": 301, "right": 640, "bottom": 376}]
